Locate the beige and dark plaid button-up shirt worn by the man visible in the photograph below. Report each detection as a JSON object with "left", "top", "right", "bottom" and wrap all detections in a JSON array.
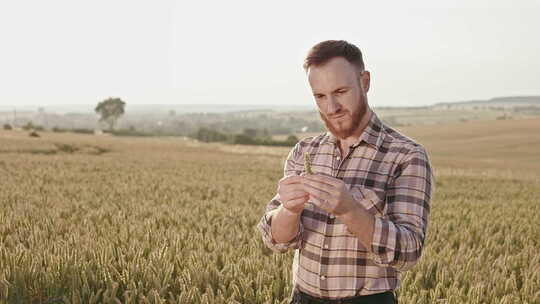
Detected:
[{"left": 257, "top": 113, "right": 433, "bottom": 299}]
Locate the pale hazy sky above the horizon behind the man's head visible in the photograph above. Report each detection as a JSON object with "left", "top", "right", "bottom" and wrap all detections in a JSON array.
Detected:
[{"left": 0, "top": 0, "right": 540, "bottom": 108}]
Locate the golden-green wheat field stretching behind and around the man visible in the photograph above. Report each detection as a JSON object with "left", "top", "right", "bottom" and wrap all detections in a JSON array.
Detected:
[{"left": 0, "top": 119, "right": 540, "bottom": 304}]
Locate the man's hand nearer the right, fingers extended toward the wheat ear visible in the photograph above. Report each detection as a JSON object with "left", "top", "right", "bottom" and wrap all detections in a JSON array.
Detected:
[{"left": 303, "top": 174, "right": 355, "bottom": 216}]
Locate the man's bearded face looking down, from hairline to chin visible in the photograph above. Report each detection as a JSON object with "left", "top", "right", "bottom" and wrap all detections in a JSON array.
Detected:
[{"left": 308, "top": 57, "right": 369, "bottom": 139}]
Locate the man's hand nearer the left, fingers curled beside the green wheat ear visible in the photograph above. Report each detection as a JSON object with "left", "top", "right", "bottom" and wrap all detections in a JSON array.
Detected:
[{"left": 278, "top": 175, "right": 309, "bottom": 214}]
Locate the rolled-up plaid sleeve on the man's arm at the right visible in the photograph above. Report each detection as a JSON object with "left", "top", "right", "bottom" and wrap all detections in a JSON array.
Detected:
[{"left": 364, "top": 147, "right": 433, "bottom": 271}]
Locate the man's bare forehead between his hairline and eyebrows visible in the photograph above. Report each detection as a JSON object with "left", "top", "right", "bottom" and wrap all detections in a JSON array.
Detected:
[{"left": 308, "top": 57, "right": 357, "bottom": 90}]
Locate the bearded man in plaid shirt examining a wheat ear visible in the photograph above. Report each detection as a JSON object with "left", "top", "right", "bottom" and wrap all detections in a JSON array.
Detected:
[{"left": 258, "top": 40, "right": 432, "bottom": 304}]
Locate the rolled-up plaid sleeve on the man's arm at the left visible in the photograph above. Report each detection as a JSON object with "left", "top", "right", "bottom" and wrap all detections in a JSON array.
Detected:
[{"left": 257, "top": 144, "right": 304, "bottom": 253}]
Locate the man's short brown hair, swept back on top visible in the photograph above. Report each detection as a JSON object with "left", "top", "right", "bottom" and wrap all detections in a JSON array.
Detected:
[{"left": 304, "top": 40, "right": 364, "bottom": 71}]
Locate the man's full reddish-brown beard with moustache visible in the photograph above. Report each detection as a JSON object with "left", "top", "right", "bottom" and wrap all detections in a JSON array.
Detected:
[{"left": 319, "top": 95, "right": 367, "bottom": 139}]
